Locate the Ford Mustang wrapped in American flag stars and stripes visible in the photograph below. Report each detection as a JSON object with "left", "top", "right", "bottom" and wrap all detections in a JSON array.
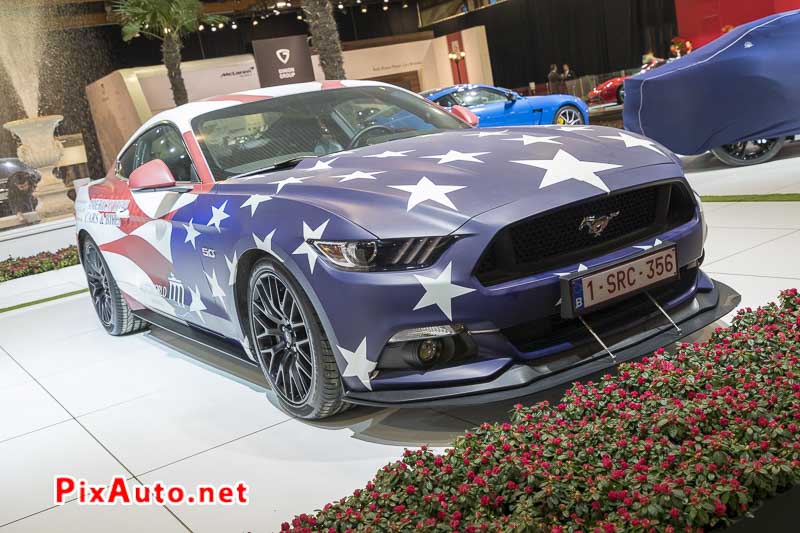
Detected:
[{"left": 76, "top": 81, "right": 738, "bottom": 418}]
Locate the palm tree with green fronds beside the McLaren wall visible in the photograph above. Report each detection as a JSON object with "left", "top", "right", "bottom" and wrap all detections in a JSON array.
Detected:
[{"left": 114, "top": 0, "right": 227, "bottom": 105}]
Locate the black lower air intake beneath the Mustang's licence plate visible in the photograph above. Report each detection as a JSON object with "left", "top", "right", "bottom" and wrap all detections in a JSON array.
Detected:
[{"left": 501, "top": 268, "right": 698, "bottom": 353}]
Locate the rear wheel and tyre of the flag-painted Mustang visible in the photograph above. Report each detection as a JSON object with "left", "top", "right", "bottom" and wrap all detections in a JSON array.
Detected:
[{"left": 82, "top": 237, "right": 147, "bottom": 337}]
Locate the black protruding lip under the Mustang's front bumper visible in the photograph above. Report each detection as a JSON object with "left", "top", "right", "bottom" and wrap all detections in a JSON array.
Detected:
[{"left": 345, "top": 272, "right": 741, "bottom": 407}]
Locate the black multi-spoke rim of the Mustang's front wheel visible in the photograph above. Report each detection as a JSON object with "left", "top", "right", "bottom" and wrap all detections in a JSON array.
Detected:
[{"left": 251, "top": 273, "right": 314, "bottom": 405}]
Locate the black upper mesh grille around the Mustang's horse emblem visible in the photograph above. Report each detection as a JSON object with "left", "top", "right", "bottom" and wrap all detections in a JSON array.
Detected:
[{"left": 475, "top": 183, "right": 694, "bottom": 285}]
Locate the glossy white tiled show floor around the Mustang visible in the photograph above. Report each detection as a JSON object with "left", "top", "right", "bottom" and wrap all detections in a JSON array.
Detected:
[{"left": 0, "top": 156, "right": 800, "bottom": 533}]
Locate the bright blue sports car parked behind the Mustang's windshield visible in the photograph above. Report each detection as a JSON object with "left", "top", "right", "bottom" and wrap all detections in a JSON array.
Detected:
[{"left": 421, "top": 85, "right": 589, "bottom": 128}]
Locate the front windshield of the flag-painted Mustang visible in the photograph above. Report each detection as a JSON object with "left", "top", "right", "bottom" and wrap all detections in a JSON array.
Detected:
[{"left": 192, "top": 86, "right": 469, "bottom": 181}]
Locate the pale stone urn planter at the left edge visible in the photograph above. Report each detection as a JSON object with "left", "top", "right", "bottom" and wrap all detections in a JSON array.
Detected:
[{"left": 3, "top": 115, "right": 72, "bottom": 218}]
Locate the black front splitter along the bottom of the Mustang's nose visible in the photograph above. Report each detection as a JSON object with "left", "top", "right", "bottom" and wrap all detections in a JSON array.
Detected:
[{"left": 345, "top": 281, "right": 741, "bottom": 407}]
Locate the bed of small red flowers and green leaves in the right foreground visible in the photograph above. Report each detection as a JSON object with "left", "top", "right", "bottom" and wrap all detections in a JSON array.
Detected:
[{"left": 283, "top": 289, "right": 800, "bottom": 533}]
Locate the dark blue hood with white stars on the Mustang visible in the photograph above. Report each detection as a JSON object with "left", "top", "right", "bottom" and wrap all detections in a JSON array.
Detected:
[{"left": 216, "top": 126, "right": 683, "bottom": 238}]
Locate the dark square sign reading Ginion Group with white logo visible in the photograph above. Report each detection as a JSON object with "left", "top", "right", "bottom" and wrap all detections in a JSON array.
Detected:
[{"left": 253, "top": 35, "right": 314, "bottom": 87}]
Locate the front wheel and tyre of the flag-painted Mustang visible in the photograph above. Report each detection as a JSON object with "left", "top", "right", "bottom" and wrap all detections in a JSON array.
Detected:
[{"left": 247, "top": 258, "right": 350, "bottom": 419}]
